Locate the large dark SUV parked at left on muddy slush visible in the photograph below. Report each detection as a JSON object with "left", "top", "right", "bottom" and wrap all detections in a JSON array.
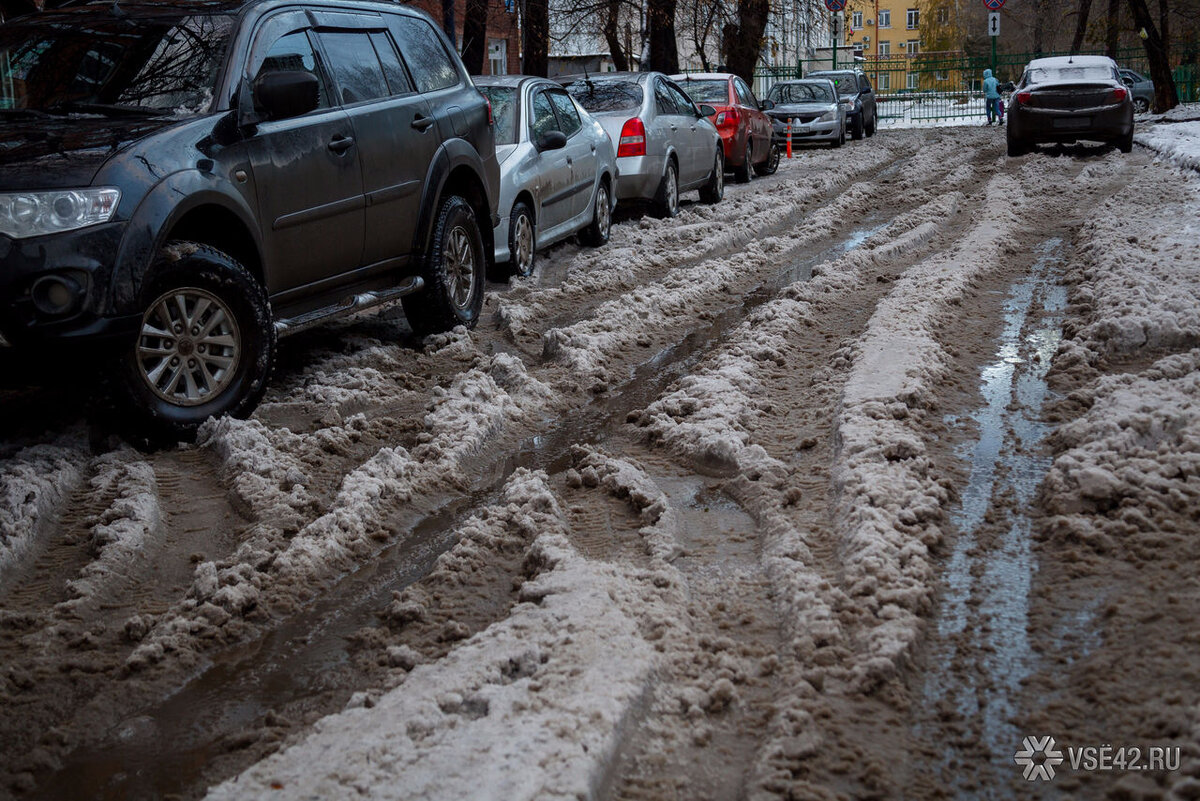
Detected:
[{"left": 0, "top": 0, "right": 499, "bottom": 439}]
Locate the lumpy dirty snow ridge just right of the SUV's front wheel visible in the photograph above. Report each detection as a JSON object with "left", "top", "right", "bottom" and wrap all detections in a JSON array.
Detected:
[{"left": 128, "top": 354, "right": 556, "bottom": 668}]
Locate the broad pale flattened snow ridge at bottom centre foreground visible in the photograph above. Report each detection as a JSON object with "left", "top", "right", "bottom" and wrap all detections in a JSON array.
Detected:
[{"left": 206, "top": 472, "right": 655, "bottom": 801}]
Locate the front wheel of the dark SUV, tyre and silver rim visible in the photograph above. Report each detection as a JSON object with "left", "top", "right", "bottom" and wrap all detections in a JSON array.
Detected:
[{"left": 118, "top": 241, "right": 275, "bottom": 442}]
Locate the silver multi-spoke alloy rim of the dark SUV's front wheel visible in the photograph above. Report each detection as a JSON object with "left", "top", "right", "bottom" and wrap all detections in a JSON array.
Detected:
[{"left": 137, "top": 287, "right": 241, "bottom": 406}]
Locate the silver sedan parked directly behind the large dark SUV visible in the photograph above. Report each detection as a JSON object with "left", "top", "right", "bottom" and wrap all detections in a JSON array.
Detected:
[{"left": 475, "top": 76, "right": 617, "bottom": 276}]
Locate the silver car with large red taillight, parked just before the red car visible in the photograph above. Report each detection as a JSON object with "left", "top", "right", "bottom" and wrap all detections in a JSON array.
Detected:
[{"left": 558, "top": 72, "right": 725, "bottom": 217}]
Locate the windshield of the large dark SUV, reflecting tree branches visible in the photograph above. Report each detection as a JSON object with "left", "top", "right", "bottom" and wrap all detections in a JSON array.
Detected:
[{"left": 0, "top": 14, "right": 234, "bottom": 116}]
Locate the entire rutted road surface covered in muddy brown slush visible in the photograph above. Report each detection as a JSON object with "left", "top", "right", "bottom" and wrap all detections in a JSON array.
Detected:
[{"left": 0, "top": 120, "right": 1200, "bottom": 801}]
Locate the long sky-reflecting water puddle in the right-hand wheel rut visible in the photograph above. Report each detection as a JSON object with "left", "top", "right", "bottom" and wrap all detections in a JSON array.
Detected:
[{"left": 925, "top": 239, "right": 1067, "bottom": 800}]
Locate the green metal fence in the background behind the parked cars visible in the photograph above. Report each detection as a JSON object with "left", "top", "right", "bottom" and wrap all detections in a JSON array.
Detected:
[{"left": 754, "top": 46, "right": 1200, "bottom": 122}]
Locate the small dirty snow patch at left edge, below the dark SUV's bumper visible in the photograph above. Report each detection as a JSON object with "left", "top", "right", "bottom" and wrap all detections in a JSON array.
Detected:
[{"left": 0, "top": 438, "right": 86, "bottom": 577}]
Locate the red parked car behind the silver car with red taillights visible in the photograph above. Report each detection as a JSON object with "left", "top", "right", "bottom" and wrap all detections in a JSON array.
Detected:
[{"left": 672, "top": 72, "right": 779, "bottom": 183}]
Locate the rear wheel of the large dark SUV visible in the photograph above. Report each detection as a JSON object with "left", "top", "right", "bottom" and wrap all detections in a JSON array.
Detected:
[{"left": 401, "top": 194, "right": 486, "bottom": 336}]
